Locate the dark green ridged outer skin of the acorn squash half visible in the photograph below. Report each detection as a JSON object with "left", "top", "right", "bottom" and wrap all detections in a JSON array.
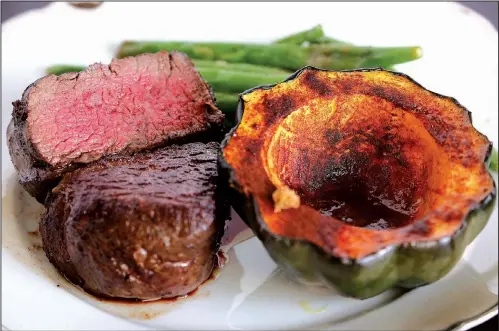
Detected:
[{"left": 219, "top": 67, "right": 496, "bottom": 299}]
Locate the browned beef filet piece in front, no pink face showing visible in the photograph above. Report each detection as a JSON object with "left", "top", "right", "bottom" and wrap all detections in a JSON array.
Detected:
[{"left": 40, "top": 142, "right": 228, "bottom": 300}]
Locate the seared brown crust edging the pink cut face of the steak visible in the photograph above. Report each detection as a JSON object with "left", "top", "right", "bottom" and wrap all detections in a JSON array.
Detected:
[{"left": 7, "top": 52, "right": 224, "bottom": 203}]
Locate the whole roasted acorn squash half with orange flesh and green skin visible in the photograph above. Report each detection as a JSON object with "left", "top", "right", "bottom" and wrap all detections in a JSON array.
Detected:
[{"left": 221, "top": 67, "right": 496, "bottom": 298}]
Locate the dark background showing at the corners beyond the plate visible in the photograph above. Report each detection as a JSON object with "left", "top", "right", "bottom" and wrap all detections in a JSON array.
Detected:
[{"left": 2, "top": 1, "right": 499, "bottom": 331}]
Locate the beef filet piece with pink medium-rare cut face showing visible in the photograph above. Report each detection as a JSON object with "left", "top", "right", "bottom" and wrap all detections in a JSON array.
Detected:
[{"left": 8, "top": 52, "right": 223, "bottom": 202}]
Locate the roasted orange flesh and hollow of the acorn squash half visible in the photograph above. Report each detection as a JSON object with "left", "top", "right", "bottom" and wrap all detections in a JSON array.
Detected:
[{"left": 223, "top": 69, "right": 494, "bottom": 259}]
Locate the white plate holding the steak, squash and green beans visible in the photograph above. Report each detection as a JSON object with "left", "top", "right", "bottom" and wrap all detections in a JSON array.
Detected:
[{"left": 1, "top": 3, "right": 498, "bottom": 330}]
